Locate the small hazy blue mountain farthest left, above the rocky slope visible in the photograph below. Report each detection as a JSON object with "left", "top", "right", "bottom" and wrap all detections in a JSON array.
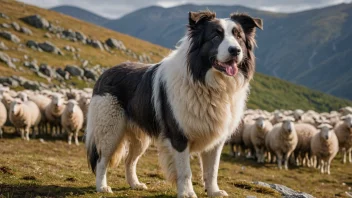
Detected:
[{"left": 50, "top": 5, "right": 110, "bottom": 26}]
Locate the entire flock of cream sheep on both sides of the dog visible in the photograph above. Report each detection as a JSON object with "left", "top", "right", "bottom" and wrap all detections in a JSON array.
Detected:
[{"left": 0, "top": 85, "right": 352, "bottom": 174}]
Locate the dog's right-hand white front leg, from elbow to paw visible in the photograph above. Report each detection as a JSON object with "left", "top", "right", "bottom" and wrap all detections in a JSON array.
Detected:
[{"left": 201, "top": 141, "right": 228, "bottom": 197}]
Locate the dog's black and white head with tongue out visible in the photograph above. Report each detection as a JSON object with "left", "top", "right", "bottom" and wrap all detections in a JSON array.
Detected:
[{"left": 188, "top": 11, "right": 263, "bottom": 82}]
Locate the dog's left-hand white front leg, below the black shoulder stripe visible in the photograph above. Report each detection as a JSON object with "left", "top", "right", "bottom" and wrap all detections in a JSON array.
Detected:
[{"left": 174, "top": 146, "right": 197, "bottom": 198}]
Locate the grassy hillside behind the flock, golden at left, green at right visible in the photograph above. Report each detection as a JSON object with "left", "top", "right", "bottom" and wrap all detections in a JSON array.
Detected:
[{"left": 0, "top": 0, "right": 352, "bottom": 111}]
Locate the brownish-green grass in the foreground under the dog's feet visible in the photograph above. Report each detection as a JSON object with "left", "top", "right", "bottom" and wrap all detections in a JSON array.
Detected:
[{"left": 0, "top": 129, "right": 352, "bottom": 198}]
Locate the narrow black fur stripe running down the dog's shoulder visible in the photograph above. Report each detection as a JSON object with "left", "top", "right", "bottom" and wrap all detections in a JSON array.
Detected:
[{"left": 159, "top": 83, "right": 188, "bottom": 152}]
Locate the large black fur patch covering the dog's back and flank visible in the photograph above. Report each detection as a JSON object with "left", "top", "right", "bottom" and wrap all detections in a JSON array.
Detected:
[{"left": 93, "top": 63, "right": 160, "bottom": 136}]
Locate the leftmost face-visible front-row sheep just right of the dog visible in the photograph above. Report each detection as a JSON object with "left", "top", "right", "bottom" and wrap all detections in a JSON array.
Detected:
[{"left": 248, "top": 116, "right": 273, "bottom": 163}]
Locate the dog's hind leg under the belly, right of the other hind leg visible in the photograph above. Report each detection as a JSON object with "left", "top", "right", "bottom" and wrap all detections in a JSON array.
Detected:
[{"left": 125, "top": 126, "right": 150, "bottom": 190}]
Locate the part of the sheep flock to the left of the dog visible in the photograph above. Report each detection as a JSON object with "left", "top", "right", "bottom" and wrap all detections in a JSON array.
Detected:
[{"left": 0, "top": 86, "right": 92, "bottom": 145}]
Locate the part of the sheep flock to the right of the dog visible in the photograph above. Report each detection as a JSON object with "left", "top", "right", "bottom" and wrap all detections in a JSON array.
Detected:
[{"left": 229, "top": 107, "right": 352, "bottom": 174}]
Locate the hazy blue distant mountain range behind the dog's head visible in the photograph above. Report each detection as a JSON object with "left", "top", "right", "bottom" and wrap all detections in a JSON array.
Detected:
[{"left": 53, "top": 4, "right": 352, "bottom": 99}]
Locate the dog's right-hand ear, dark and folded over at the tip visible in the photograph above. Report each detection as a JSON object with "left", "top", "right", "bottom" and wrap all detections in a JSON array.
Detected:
[{"left": 230, "top": 13, "right": 263, "bottom": 34}]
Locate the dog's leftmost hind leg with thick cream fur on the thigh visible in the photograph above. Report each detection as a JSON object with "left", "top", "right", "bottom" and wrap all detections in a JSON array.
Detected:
[{"left": 86, "top": 95, "right": 126, "bottom": 193}]
